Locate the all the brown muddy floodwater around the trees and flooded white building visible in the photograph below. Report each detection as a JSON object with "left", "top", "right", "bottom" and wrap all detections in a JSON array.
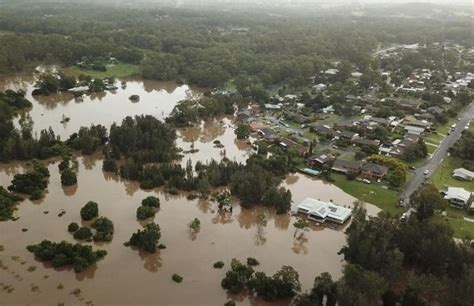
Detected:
[{"left": 0, "top": 73, "right": 377, "bottom": 305}]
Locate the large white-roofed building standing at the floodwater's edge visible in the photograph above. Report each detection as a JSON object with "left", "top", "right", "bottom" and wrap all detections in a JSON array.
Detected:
[{"left": 297, "top": 198, "right": 352, "bottom": 224}]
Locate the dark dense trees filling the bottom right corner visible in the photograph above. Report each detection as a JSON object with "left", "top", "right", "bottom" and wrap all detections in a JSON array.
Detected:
[{"left": 295, "top": 203, "right": 474, "bottom": 306}]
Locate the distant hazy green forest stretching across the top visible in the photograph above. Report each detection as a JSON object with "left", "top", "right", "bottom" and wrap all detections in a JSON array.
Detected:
[{"left": 0, "top": 4, "right": 470, "bottom": 86}]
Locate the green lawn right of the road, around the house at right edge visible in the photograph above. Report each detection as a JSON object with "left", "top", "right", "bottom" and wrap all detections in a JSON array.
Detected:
[{"left": 430, "top": 156, "right": 474, "bottom": 192}]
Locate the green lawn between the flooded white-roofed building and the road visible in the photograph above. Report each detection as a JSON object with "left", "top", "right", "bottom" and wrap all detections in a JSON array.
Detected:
[{"left": 331, "top": 173, "right": 401, "bottom": 216}]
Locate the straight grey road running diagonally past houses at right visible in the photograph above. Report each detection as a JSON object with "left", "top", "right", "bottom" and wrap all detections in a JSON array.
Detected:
[{"left": 400, "top": 103, "right": 474, "bottom": 208}]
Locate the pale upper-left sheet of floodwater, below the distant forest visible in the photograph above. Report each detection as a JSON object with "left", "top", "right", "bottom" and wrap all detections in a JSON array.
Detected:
[{"left": 0, "top": 75, "right": 199, "bottom": 140}]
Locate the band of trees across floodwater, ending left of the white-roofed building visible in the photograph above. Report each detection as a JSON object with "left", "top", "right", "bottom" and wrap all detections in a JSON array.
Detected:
[{"left": 113, "top": 154, "right": 291, "bottom": 213}]
